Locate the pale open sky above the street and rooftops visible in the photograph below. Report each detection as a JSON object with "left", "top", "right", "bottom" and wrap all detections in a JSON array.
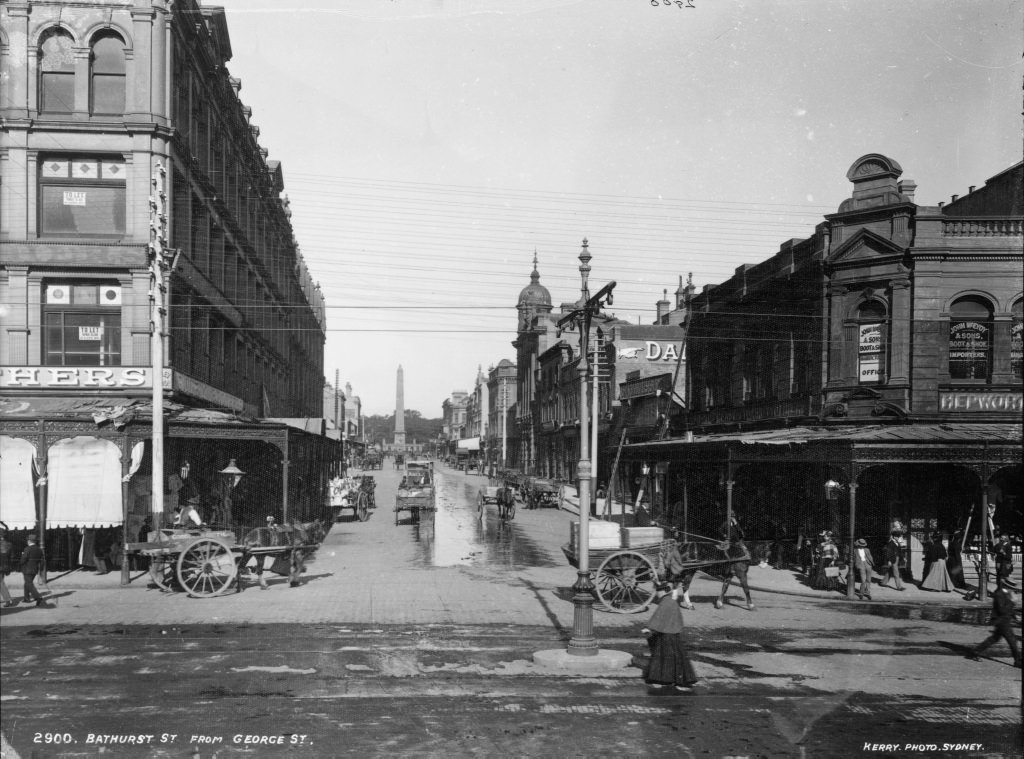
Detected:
[{"left": 211, "top": 0, "right": 1024, "bottom": 417}]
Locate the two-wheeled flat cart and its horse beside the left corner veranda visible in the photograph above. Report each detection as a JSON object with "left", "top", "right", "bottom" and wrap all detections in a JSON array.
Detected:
[{"left": 126, "top": 526, "right": 319, "bottom": 598}]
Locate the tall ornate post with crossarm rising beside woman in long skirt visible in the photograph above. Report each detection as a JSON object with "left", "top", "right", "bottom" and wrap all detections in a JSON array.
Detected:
[{"left": 558, "top": 238, "right": 615, "bottom": 657}]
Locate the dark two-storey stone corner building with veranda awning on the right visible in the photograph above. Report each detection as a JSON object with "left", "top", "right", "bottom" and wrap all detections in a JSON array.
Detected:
[{"left": 626, "top": 154, "right": 1024, "bottom": 577}]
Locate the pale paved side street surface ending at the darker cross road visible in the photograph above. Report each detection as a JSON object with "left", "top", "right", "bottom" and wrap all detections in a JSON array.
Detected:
[{"left": 0, "top": 467, "right": 999, "bottom": 629}]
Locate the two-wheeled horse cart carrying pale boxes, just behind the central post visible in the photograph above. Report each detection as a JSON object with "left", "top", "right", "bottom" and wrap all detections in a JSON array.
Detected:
[{"left": 562, "top": 538, "right": 735, "bottom": 614}]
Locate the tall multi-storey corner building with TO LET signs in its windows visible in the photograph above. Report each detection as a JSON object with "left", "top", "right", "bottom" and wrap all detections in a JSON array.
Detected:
[{"left": 0, "top": 0, "right": 333, "bottom": 569}]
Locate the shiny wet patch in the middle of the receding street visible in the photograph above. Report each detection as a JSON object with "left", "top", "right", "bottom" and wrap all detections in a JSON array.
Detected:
[{"left": 403, "top": 472, "right": 558, "bottom": 570}]
